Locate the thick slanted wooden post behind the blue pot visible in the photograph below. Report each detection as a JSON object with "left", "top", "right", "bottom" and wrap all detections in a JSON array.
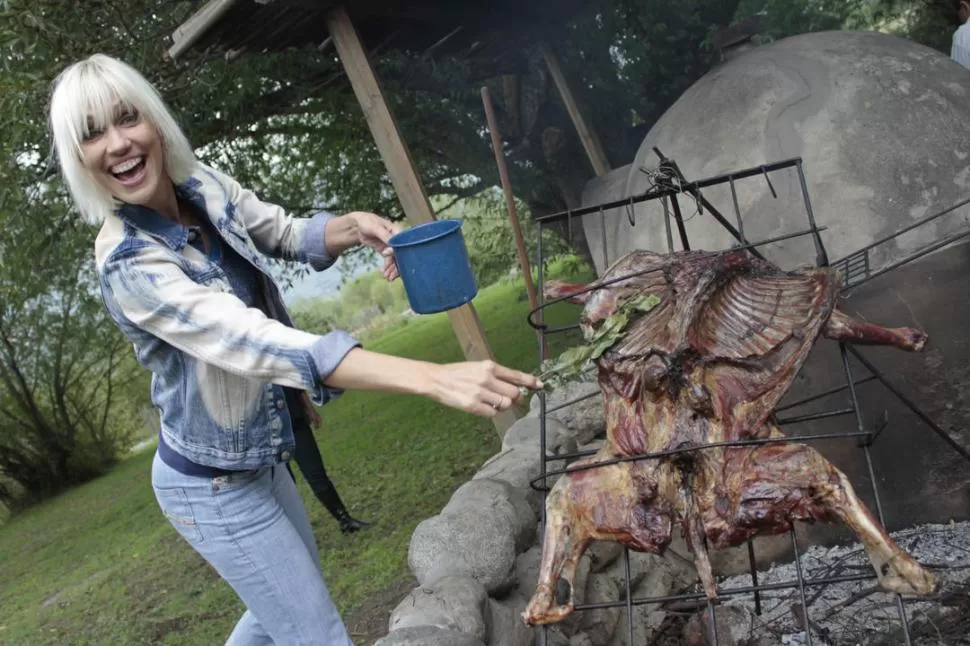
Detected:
[{"left": 327, "top": 6, "right": 518, "bottom": 438}]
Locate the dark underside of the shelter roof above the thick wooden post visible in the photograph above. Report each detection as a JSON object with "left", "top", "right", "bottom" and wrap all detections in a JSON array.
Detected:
[{"left": 169, "top": 0, "right": 583, "bottom": 57}]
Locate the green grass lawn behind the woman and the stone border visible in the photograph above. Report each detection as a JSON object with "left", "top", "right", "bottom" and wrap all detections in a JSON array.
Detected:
[{"left": 0, "top": 264, "right": 577, "bottom": 646}]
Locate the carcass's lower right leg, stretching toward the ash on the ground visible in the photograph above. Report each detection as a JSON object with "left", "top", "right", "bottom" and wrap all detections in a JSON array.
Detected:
[{"left": 729, "top": 442, "right": 939, "bottom": 595}]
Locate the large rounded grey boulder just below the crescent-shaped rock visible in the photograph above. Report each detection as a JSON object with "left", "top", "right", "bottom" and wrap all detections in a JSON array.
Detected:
[{"left": 408, "top": 509, "right": 516, "bottom": 594}]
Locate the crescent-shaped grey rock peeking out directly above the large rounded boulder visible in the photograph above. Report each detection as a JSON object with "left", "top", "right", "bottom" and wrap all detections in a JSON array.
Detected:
[{"left": 441, "top": 478, "right": 538, "bottom": 552}]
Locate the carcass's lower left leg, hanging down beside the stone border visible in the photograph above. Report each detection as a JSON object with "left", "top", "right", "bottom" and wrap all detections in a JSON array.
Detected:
[{"left": 522, "top": 456, "right": 670, "bottom": 625}]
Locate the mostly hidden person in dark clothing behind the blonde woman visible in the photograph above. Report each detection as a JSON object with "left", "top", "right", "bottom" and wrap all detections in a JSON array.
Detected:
[{"left": 287, "top": 389, "right": 371, "bottom": 534}]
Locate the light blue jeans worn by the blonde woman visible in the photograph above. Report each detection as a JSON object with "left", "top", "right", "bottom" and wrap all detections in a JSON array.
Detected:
[{"left": 152, "top": 455, "right": 354, "bottom": 646}]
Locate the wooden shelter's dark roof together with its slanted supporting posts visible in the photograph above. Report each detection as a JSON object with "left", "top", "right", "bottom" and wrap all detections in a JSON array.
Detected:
[{"left": 168, "top": 0, "right": 598, "bottom": 437}]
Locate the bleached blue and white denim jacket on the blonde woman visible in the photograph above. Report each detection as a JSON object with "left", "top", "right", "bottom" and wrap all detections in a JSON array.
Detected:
[{"left": 95, "top": 164, "right": 359, "bottom": 470}]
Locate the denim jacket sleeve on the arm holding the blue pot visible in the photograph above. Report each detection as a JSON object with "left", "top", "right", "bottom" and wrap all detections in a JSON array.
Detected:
[{"left": 195, "top": 165, "right": 337, "bottom": 271}]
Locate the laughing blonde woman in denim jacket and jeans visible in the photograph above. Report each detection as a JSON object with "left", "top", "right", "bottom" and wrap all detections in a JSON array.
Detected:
[{"left": 50, "top": 55, "right": 541, "bottom": 646}]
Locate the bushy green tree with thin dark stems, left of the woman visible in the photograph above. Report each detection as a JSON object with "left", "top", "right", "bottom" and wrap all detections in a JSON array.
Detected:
[{"left": 0, "top": 128, "right": 144, "bottom": 507}]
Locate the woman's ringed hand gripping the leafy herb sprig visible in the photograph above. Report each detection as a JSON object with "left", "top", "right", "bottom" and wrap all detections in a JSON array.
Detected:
[{"left": 430, "top": 361, "right": 542, "bottom": 417}]
